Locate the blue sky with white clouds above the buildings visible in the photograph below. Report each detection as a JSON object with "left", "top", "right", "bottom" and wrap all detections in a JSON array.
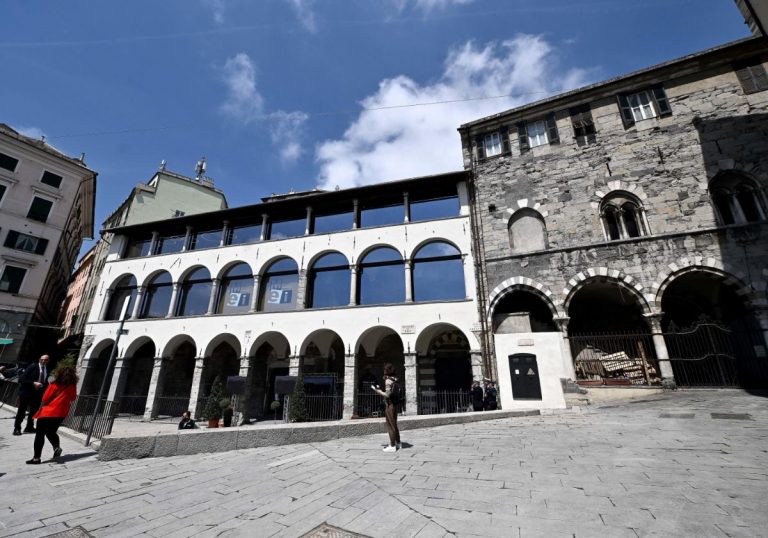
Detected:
[{"left": 0, "top": 0, "right": 748, "bottom": 252}]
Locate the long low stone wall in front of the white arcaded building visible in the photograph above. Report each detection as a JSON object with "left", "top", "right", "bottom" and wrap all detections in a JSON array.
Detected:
[{"left": 98, "top": 409, "right": 541, "bottom": 461}]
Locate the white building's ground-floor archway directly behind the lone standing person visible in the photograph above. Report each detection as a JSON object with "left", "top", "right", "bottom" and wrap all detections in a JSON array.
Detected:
[{"left": 354, "top": 327, "right": 407, "bottom": 418}]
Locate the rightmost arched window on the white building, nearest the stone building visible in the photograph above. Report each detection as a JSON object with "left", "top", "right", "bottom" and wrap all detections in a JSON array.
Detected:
[{"left": 411, "top": 241, "right": 467, "bottom": 301}]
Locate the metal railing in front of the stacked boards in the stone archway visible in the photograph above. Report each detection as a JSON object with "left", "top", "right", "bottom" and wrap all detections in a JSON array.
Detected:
[{"left": 568, "top": 333, "right": 661, "bottom": 385}]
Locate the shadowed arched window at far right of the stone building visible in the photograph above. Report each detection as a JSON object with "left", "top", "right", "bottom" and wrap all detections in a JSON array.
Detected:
[{"left": 709, "top": 172, "right": 766, "bottom": 224}]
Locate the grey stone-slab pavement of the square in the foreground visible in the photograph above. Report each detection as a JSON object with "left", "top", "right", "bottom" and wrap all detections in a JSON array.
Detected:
[{"left": 0, "top": 391, "right": 768, "bottom": 538}]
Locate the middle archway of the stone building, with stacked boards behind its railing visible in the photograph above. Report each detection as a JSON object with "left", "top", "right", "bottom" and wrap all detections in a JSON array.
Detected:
[{"left": 566, "top": 278, "right": 661, "bottom": 385}]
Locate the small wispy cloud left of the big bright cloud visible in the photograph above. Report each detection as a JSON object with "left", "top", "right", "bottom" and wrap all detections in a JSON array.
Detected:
[{"left": 220, "top": 52, "right": 308, "bottom": 164}]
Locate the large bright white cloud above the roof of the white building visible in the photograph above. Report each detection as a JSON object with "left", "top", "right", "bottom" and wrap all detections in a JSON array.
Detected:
[{"left": 316, "top": 35, "right": 587, "bottom": 189}]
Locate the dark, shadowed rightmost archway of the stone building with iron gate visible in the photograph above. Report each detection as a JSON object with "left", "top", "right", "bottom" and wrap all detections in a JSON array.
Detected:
[{"left": 661, "top": 269, "right": 768, "bottom": 388}]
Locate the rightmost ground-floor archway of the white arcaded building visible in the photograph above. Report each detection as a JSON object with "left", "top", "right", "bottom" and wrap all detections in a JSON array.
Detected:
[{"left": 416, "top": 324, "right": 472, "bottom": 415}]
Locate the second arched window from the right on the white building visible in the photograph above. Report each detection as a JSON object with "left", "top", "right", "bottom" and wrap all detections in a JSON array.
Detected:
[{"left": 357, "top": 247, "right": 405, "bottom": 304}]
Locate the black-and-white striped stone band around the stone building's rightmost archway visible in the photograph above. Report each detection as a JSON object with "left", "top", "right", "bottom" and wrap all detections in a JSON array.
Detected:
[{"left": 651, "top": 256, "right": 768, "bottom": 311}]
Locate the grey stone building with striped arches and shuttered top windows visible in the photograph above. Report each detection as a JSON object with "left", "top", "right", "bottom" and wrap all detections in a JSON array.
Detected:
[{"left": 459, "top": 37, "right": 768, "bottom": 400}]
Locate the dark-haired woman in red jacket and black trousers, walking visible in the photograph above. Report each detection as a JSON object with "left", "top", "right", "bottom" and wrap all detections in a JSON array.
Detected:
[{"left": 27, "top": 366, "right": 77, "bottom": 465}]
